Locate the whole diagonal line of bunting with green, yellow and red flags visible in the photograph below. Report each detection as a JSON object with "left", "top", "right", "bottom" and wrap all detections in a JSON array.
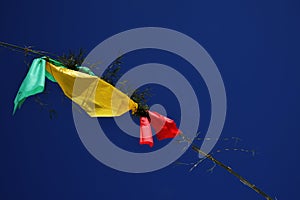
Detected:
[{"left": 0, "top": 41, "right": 273, "bottom": 200}]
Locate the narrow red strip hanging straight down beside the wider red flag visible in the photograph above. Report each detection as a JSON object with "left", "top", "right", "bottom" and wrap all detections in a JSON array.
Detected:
[{"left": 140, "top": 117, "right": 153, "bottom": 147}]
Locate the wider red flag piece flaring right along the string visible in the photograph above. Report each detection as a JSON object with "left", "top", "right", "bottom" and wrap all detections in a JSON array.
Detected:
[{"left": 149, "top": 111, "right": 181, "bottom": 140}]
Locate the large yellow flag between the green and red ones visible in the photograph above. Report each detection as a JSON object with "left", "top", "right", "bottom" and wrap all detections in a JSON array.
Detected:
[{"left": 46, "top": 62, "right": 138, "bottom": 117}]
